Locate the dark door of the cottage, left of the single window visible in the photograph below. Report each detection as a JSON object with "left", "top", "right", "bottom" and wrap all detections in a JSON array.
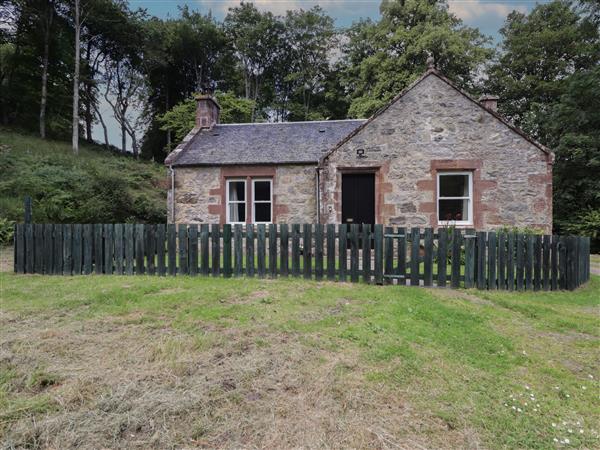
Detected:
[{"left": 342, "top": 173, "right": 375, "bottom": 225}]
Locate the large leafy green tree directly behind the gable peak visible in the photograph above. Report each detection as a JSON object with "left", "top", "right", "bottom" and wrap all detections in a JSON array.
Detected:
[{"left": 343, "top": 0, "right": 492, "bottom": 117}]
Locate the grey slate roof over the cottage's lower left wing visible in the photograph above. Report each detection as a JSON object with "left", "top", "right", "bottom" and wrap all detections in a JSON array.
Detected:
[{"left": 165, "top": 120, "right": 365, "bottom": 166}]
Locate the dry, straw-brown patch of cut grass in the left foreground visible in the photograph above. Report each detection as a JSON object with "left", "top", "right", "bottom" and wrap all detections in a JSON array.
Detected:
[{"left": 0, "top": 316, "right": 472, "bottom": 449}]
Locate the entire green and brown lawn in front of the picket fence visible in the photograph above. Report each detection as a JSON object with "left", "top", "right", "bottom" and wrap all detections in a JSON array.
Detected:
[{"left": 0, "top": 273, "right": 600, "bottom": 448}]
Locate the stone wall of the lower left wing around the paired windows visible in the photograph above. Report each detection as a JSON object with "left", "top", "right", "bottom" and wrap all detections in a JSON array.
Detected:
[{"left": 168, "top": 165, "right": 317, "bottom": 223}]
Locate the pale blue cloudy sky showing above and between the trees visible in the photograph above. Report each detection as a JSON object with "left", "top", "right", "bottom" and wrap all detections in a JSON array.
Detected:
[{"left": 94, "top": 0, "right": 549, "bottom": 151}]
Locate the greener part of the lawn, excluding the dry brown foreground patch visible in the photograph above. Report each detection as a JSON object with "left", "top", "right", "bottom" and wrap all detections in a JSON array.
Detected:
[{"left": 0, "top": 274, "right": 600, "bottom": 448}]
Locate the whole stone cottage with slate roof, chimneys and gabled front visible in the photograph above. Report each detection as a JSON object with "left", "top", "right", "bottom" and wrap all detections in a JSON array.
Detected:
[{"left": 165, "top": 68, "right": 553, "bottom": 232}]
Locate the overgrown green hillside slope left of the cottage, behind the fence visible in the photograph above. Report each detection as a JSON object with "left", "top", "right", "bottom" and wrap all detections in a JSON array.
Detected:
[{"left": 0, "top": 128, "right": 167, "bottom": 223}]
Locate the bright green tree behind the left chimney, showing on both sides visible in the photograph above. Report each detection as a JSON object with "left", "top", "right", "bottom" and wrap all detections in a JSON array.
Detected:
[{"left": 158, "top": 92, "right": 254, "bottom": 146}]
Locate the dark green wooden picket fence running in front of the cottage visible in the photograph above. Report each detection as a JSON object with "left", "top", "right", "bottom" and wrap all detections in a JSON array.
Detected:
[{"left": 14, "top": 223, "right": 590, "bottom": 290}]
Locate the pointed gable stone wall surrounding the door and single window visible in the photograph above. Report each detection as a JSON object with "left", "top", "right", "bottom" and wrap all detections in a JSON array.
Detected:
[{"left": 321, "top": 74, "right": 552, "bottom": 232}]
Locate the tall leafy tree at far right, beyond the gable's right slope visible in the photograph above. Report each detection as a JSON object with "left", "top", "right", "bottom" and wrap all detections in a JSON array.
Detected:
[{"left": 486, "top": 0, "right": 600, "bottom": 144}]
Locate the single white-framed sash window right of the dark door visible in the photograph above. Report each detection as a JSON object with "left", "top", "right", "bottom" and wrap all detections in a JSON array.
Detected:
[{"left": 437, "top": 172, "right": 473, "bottom": 225}]
